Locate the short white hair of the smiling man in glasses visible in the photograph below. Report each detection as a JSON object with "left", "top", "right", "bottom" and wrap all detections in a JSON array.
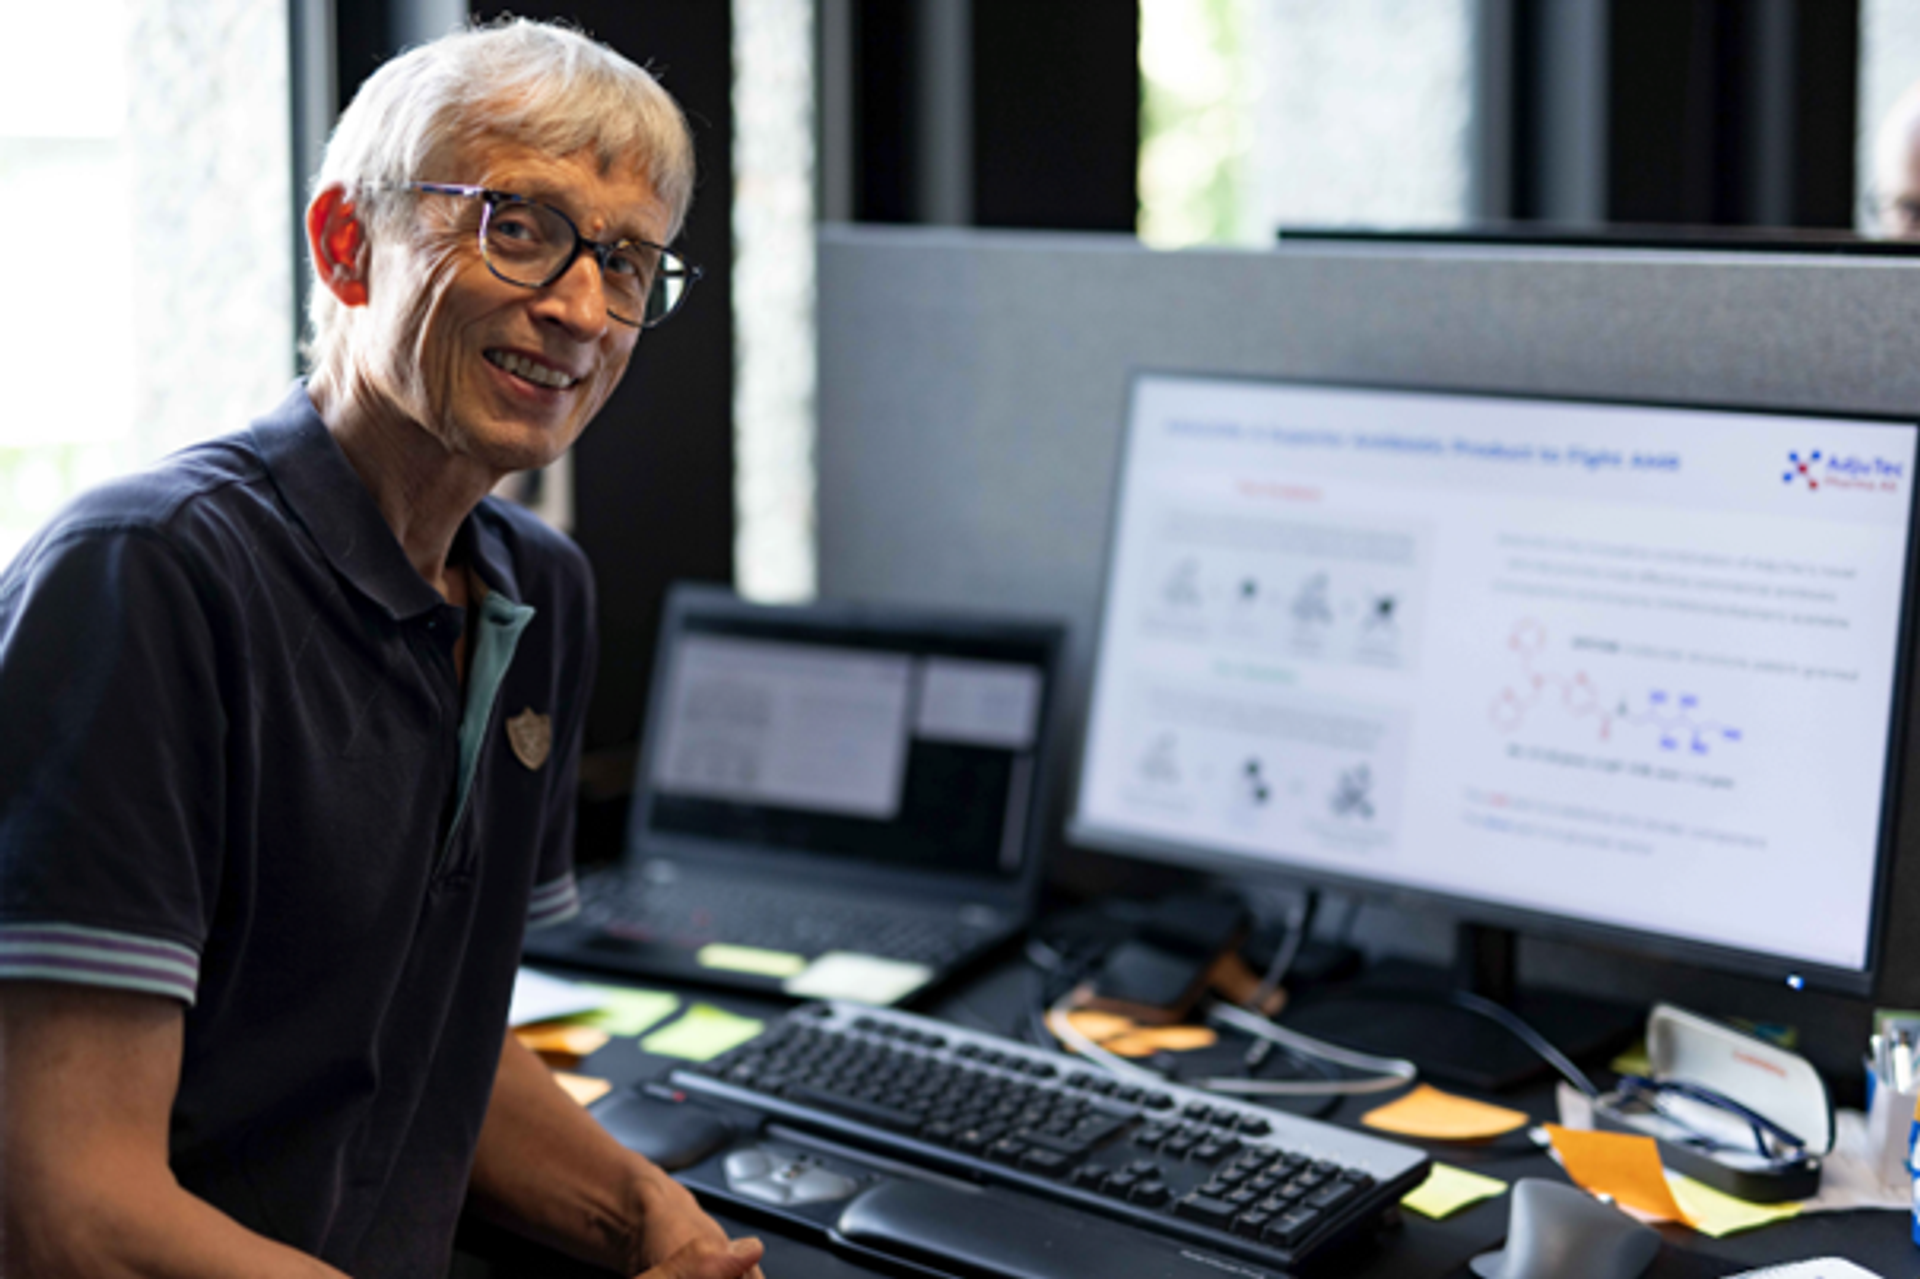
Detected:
[{"left": 307, "top": 17, "right": 693, "bottom": 371}]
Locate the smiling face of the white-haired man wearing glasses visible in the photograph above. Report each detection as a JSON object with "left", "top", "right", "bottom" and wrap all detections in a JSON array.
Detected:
[{"left": 361, "top": 142, "right": 668, "bottom": 478}]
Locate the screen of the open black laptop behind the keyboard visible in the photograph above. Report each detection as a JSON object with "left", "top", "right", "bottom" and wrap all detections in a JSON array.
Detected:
[{"left": 641, "top": 597, "right": 1058, "bottom": 878}]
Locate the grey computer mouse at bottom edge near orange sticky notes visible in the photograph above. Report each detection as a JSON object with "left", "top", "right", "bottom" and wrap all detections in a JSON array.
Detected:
[{"left": 1467, "top": 1177, "right": 1661, "bottom": 1279}]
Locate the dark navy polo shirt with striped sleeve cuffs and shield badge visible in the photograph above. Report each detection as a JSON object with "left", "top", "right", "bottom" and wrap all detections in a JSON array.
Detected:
[{"left": 0, "top": 386, "right": 593, "bottom": 1279}]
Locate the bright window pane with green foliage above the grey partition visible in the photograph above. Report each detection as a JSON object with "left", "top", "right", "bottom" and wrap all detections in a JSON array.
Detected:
[{"left": 1139, "top": 0, "right": 1475, "bottom": 248}]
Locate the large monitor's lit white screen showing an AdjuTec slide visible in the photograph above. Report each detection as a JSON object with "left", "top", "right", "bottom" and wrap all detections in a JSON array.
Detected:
[{"left": 1071, "top": 374, "right": 1916, "bottom": 985}]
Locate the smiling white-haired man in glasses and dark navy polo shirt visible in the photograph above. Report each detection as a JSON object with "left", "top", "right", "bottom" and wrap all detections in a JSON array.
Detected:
[{"left": 0, "top": 23, "right": 760, "bottom": 1279}]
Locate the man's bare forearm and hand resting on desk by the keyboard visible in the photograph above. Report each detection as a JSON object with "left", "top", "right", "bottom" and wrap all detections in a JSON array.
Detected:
[{"left": 472, "top": 1035, "right": 760, "bottom": 1279}]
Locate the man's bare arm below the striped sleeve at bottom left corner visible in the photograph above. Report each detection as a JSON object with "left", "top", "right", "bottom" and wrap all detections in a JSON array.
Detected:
[{"left": 0, "top": 981, "right": 340, "bottom": 1279}]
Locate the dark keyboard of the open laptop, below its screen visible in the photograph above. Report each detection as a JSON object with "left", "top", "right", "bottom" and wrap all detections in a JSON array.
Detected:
[{"left": 580, "top": 874, "right": 989, "bottom": 968}]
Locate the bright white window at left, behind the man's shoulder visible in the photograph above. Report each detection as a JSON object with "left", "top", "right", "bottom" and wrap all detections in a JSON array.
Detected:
[{"left": 0, "top": 0, "right": 294, "bottom": 559}]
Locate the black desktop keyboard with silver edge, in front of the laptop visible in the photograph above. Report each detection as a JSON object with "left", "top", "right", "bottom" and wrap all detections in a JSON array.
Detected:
[{"left": 670, "top": 1004, "right": 1428, "bottom": 1273}]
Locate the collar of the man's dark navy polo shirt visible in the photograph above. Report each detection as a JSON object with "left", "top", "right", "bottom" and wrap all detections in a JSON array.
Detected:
[{"left": 252, "top": 380, "right": 520, "bottom": 618}]
